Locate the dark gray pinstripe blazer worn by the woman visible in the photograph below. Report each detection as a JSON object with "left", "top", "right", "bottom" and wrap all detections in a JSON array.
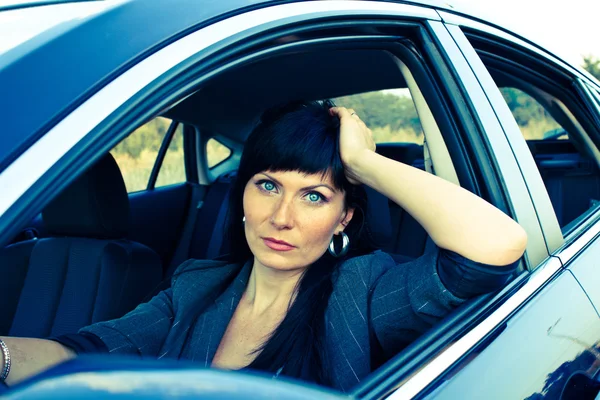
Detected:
[{"left": 80, "top": 247, "right": 464, "bottom": 391}]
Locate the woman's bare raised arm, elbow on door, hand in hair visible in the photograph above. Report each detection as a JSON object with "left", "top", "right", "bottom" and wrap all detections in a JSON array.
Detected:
[{"left": 331, "top": 107, "right": 527, "bottom": 265}]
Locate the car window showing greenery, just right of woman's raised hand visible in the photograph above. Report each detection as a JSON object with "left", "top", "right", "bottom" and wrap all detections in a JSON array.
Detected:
[{"left": 334, "top": 89, "right": 424, "bottom": 145}]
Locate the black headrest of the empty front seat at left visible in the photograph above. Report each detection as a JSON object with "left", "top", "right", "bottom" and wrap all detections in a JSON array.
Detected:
[{"left": 42, "top": 153, "right": 129, "bottom": 239}]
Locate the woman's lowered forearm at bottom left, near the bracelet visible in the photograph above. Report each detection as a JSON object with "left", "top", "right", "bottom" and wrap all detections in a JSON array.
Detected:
[{"left": 0, "top": 337, "right": 76, "bottom": 386}]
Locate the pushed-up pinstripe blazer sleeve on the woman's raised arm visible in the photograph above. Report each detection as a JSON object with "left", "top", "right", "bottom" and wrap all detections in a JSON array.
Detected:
[{"left": 369, "top": 246, "right": 518, "bottom": 354}]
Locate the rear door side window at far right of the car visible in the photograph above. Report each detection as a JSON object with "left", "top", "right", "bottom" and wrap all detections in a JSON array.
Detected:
[{"left": 468, "top": 35, "right": 600, "bottom": 235}]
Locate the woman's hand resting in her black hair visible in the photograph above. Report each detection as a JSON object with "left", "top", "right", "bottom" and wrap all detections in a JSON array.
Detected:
[{"left": 329, "top": 107, "right": 375, "bottom": 185}]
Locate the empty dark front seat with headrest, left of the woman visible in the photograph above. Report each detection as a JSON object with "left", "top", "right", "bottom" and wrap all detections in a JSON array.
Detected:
[{"left": 0, "top": 154, "right": 162, "bottom": 338}]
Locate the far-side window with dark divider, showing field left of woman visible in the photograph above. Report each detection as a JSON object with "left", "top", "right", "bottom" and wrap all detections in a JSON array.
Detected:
[{"left": 110, "top": 117, "right": 180, "bottom": 193}]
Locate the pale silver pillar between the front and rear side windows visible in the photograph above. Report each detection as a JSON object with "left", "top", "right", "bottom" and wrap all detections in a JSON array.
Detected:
[{"left": 430, "top": 23, "right": 548, "bottom": 270}]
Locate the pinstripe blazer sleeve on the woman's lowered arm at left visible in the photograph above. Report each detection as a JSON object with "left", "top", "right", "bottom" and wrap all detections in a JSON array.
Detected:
[{"left": 79, "top": 260, "right": 193, "bottom": 357}]
